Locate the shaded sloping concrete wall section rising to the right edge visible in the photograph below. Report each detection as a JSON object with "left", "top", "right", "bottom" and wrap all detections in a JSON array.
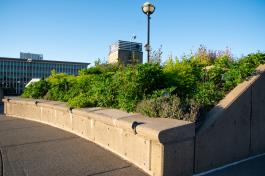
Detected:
[{"left": 194, "top": 65, "right": 265, "bottom": 173}]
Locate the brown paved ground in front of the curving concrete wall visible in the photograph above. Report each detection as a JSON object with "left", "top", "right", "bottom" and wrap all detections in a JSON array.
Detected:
[{"left": 0, "top": 116, "right": 146, "bottom": 176}]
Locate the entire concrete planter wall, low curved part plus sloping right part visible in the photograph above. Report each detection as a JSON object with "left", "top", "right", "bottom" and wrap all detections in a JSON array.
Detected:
[{"left": 3, "top": 65, "right": 265, "bottom": 176}]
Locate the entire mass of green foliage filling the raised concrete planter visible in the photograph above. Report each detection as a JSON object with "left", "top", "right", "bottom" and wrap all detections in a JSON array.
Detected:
[{"left": 22, "top": 48, "right": 265, "bottom": 121}]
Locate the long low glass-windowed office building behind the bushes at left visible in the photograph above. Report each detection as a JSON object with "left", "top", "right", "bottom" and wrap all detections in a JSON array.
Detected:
[{"left": 0, "top": 57, "right": 89, "bottom": 95}]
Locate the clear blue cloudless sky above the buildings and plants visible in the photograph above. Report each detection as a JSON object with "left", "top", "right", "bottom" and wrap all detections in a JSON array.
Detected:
[{"left": 0, "top": 0, "right": 265, "bottom": 63}]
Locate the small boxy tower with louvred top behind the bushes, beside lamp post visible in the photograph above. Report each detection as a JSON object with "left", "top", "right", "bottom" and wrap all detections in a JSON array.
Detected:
[{"left": 108, "top": 40, "right": 143, "bottom": 65}]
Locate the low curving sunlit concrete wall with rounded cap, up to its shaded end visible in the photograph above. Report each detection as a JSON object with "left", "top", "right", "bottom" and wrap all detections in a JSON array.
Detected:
[{"left": 3, "top": 97, "right": 195, "bottom": 176}]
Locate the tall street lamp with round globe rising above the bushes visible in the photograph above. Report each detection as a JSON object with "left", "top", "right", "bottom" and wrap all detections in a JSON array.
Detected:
[{"left": 142, "top": 2, "right": 155, "bottom": 63}]
